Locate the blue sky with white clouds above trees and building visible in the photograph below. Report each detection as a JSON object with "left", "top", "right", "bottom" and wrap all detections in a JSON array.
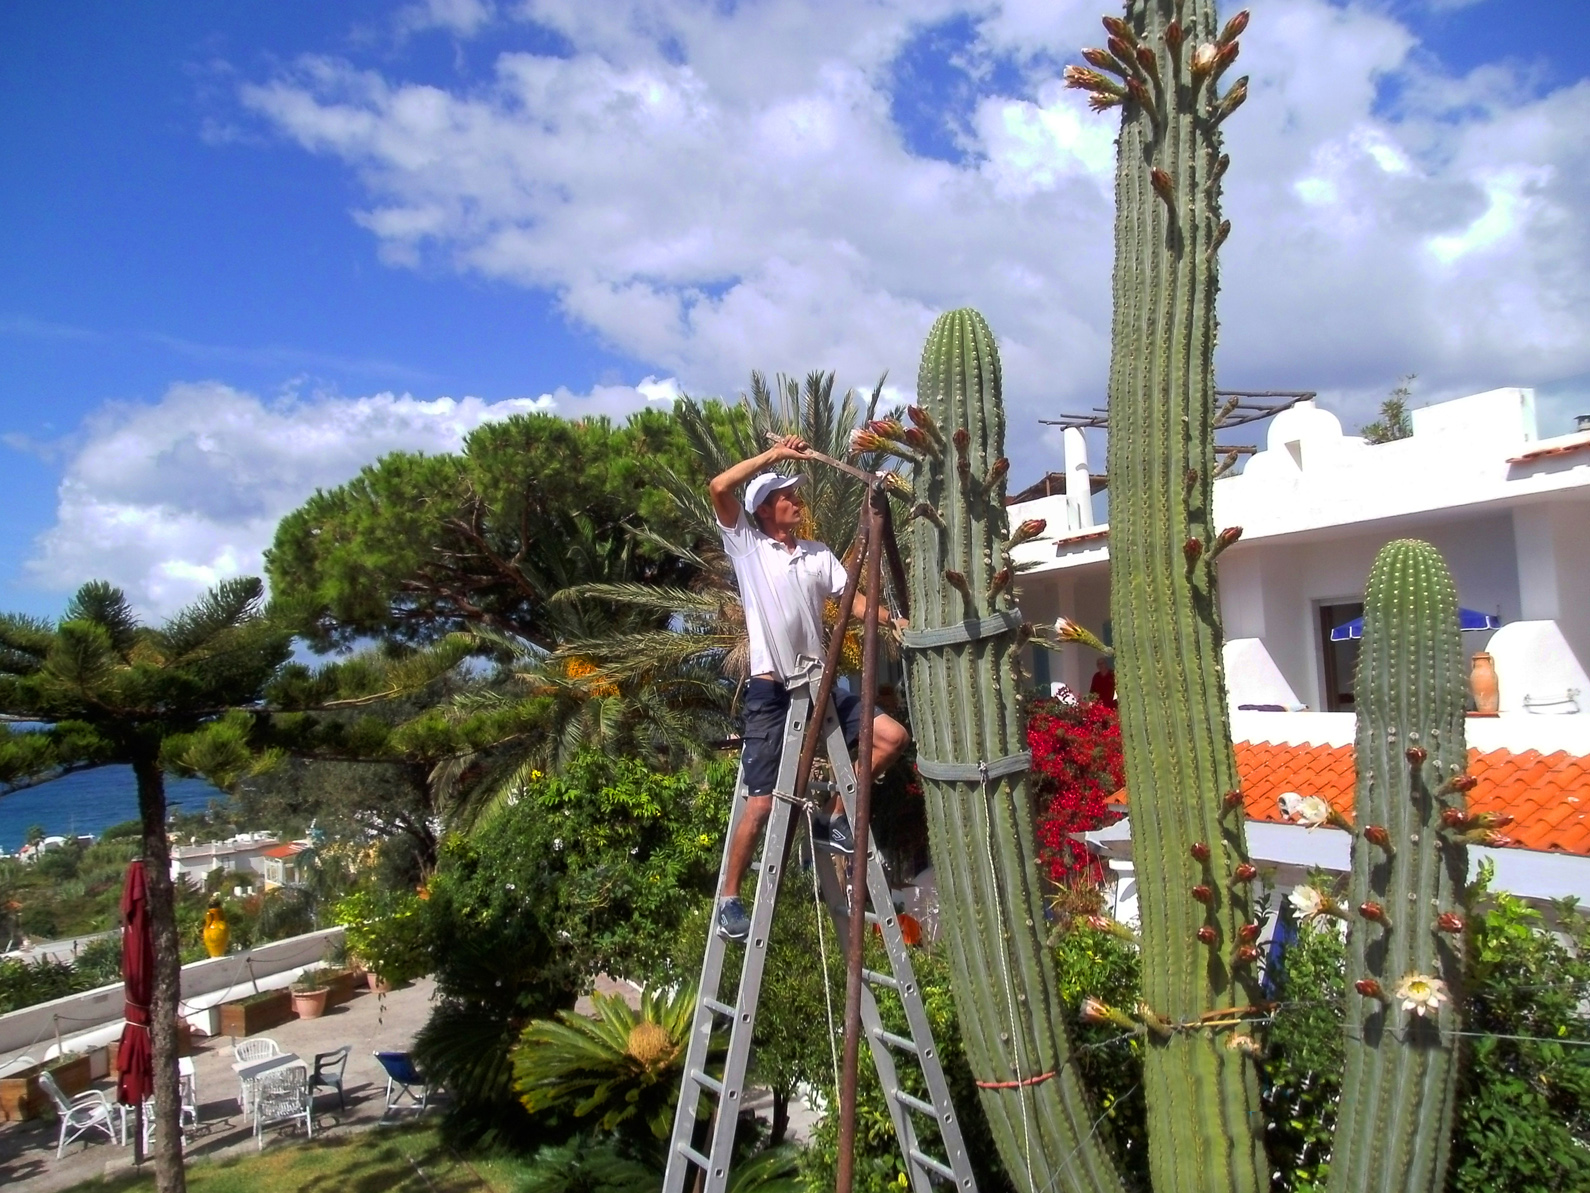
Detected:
[{"left": 0, "top": 0, "right": 1590, "bottom": 612}]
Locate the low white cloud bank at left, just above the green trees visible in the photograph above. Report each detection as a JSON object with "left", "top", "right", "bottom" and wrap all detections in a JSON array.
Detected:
[{"left": 27, "top": 377, "right": 679, "bottom": 614}]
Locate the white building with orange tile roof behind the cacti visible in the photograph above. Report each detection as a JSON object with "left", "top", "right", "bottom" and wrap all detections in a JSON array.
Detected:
[{"left": 1010, "top": 388, "right": 1590, "bottom": 910}]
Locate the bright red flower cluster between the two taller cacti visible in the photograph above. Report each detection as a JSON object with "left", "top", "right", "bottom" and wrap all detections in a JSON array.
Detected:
[{"left": 1027, "top": 700, "right": 1126, "bottom": 884}]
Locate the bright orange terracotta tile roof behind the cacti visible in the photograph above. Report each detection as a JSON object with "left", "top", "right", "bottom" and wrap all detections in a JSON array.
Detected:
[{"left": 1115, "top": 741, "right": 1590, "bottom": 856}]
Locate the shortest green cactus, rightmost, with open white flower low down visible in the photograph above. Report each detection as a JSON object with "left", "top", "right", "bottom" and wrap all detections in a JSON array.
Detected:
[{"left": 1331, "top": 539, "right": 1462, "bottom": 1193}]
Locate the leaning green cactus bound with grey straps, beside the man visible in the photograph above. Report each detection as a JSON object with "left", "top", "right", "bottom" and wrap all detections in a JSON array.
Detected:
[{"left": 906, "top": 310, "right": 1121, "bottom": 1191}]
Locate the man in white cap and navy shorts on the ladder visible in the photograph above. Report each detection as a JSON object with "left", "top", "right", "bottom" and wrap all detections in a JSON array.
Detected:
[{"left": 709, "top": 436, "right": 908, "bottom": 940}]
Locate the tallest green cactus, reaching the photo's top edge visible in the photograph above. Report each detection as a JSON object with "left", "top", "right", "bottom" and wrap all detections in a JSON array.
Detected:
[{"left": 1067, "top": 0, "right": 1269, "bottom": 1193}]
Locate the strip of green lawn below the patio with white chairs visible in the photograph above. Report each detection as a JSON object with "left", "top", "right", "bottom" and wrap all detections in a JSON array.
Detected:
[{"left": 78, "top": 1126, "right": 522, "bottom": 1193}]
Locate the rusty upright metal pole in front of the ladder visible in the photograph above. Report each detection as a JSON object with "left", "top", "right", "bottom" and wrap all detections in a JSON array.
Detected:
[{"left": 835, "top": 485, "right": 887, "bottom": 1193}]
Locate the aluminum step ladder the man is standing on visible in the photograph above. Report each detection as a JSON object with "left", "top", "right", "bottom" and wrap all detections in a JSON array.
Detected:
[{"left": 663, "top": 666, "right": 976, "bottom": 1193}]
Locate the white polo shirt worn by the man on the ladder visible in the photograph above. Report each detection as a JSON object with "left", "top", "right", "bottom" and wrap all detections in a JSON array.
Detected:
[{"left": 717, "top": 511, "right": 844, "bottom": 679}]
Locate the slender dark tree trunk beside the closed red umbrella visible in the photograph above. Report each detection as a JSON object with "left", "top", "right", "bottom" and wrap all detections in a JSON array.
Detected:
[{"left": 132, "top": 751, "right": 188, "bottom": 1193}]
